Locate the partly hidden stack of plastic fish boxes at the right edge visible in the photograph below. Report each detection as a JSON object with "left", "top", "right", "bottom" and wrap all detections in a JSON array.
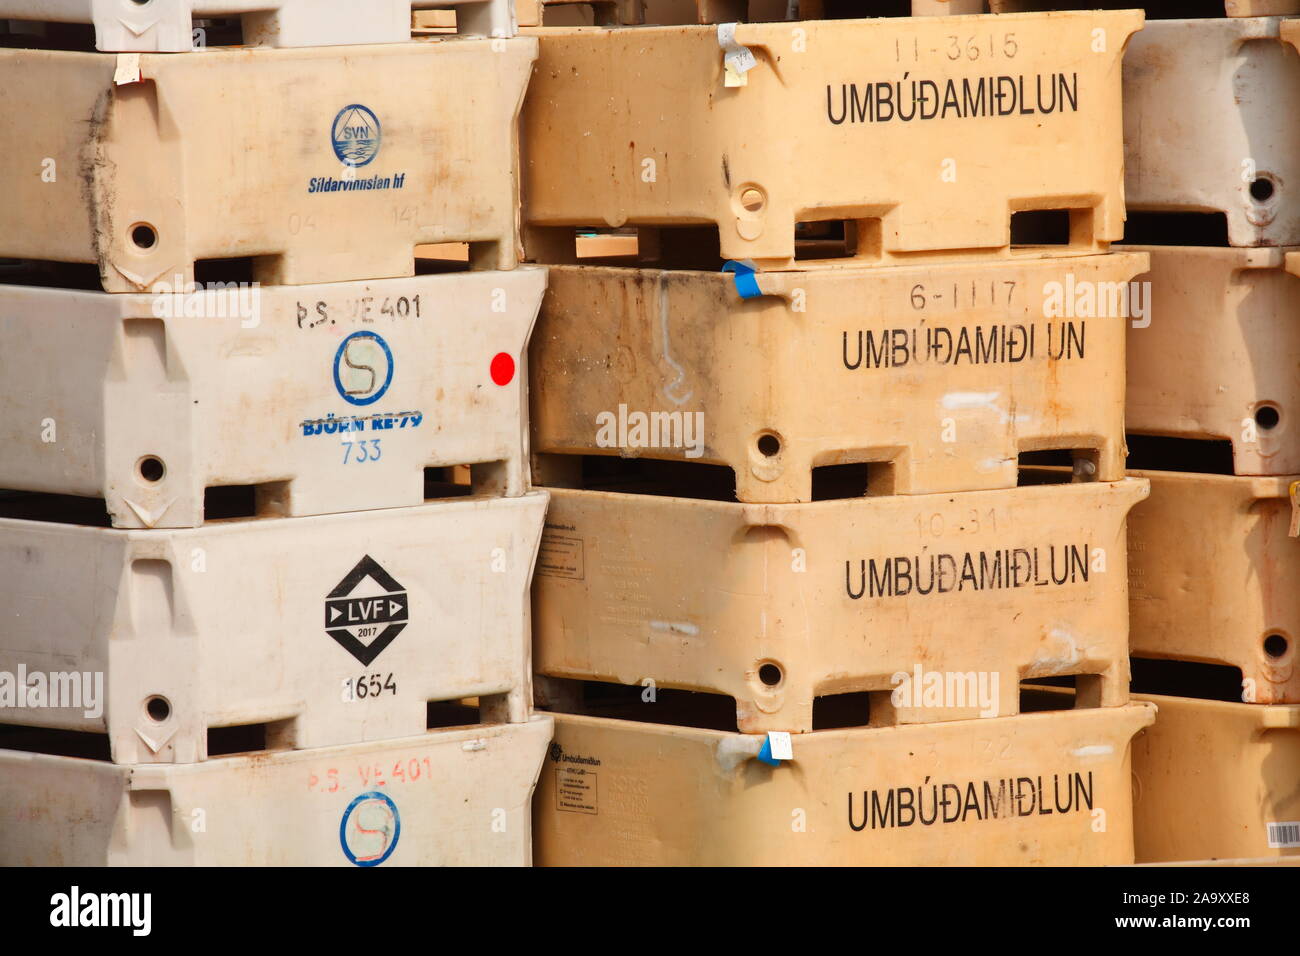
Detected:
[{"left": 1102, "top": 4, "right": 1300, "bottom": 862}]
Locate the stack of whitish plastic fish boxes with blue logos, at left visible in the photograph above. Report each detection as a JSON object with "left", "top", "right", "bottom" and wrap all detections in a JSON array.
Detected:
[{"left": 0, "top": 0, "right": 551, "bottom": 866}]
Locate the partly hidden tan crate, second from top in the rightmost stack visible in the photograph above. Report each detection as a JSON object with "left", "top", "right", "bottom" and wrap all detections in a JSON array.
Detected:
[{"left": 1126, "top": 246, "right": 1300, "bottom": 475}]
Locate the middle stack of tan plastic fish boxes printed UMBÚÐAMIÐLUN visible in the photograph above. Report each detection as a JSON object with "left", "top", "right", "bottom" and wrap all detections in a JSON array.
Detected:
[{"left": 523, "top": 7, "right": 1154, "bottom": 865}]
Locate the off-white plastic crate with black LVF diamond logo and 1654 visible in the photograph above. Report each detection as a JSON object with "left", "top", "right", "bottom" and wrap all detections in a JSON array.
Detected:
[{"left": 0, "top": 492, "right": 546, "bottom": 763}]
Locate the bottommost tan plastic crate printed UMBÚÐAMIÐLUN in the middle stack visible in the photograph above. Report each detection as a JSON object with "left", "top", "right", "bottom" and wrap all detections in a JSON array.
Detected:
[{"left": 533, "top": 705, "right": 1154, "bottom": 866}]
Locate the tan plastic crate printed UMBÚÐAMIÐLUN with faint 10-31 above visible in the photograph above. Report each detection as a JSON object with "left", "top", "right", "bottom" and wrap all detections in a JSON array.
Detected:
[{"left": 533, "top": 481, "right": 1147, "bottom": 732}]
